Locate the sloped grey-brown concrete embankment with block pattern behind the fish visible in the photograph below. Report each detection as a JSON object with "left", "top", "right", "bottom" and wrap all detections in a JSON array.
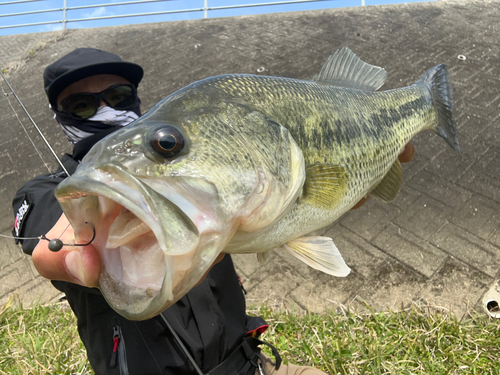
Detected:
[{"left": 0, "top": 1, "right": 500, "bottom": 318}]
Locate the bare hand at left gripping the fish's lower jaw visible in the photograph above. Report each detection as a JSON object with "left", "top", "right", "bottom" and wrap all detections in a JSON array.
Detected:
[{"left": 32, "top": 214, "right": 101, "bottom": 287}]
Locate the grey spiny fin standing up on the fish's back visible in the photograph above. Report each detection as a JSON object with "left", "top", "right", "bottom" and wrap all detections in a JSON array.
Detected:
[{"left": 313, "top": 47, "right": 387, "bottom": 91}]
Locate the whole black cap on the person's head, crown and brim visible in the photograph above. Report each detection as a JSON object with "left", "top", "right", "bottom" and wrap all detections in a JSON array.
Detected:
[{"left": 43, "top": 48, "right": 144, "bottom": 108}]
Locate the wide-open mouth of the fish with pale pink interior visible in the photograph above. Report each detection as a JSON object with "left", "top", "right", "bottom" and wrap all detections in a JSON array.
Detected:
[{"left": 56, "top": 166, "right": 199, "bottom": 320}]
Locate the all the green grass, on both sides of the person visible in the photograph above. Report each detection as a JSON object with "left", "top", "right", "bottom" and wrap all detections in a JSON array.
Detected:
[{"left": 0, "top": 299, "right": 500, "bottom": 375}]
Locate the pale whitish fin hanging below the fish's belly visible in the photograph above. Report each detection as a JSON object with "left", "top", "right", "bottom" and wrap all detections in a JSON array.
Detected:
[{"left": 283, "top": 236, "right": 351, "bottom": 277}]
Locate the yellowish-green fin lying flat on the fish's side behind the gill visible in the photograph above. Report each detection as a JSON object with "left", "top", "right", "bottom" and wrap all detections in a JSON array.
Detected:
[{"left": 301, "top": 163, "right": 348, "bottom": 209}]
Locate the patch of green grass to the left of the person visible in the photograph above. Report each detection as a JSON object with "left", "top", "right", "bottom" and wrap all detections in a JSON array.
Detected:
[{"left": 0, "top": 298, "right": 93, "bottom": 375}]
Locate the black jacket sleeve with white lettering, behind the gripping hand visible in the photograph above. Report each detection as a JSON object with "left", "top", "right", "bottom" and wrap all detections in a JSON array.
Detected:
[{"left": 12, "top": 175, "right": 63, "bottom": 255}]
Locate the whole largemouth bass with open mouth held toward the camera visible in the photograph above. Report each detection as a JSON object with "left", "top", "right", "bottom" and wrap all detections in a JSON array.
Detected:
[{"left": 56, "top": 48, "right": 459, "bottom": 320}]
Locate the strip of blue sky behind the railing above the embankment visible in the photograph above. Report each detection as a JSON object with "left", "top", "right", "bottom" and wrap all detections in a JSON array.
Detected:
[{"left": 0, "top": 0, "right": 432, "bottom": 36}]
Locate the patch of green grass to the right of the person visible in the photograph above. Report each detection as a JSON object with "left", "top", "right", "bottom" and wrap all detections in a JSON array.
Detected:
[{"left": 254, "top": 305, "right": 500, "bottom": 375}]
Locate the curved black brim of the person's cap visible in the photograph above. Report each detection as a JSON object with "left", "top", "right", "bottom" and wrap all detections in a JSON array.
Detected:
[{"left": 47, "top": 61, "right": 144, "bottom": 108}]
